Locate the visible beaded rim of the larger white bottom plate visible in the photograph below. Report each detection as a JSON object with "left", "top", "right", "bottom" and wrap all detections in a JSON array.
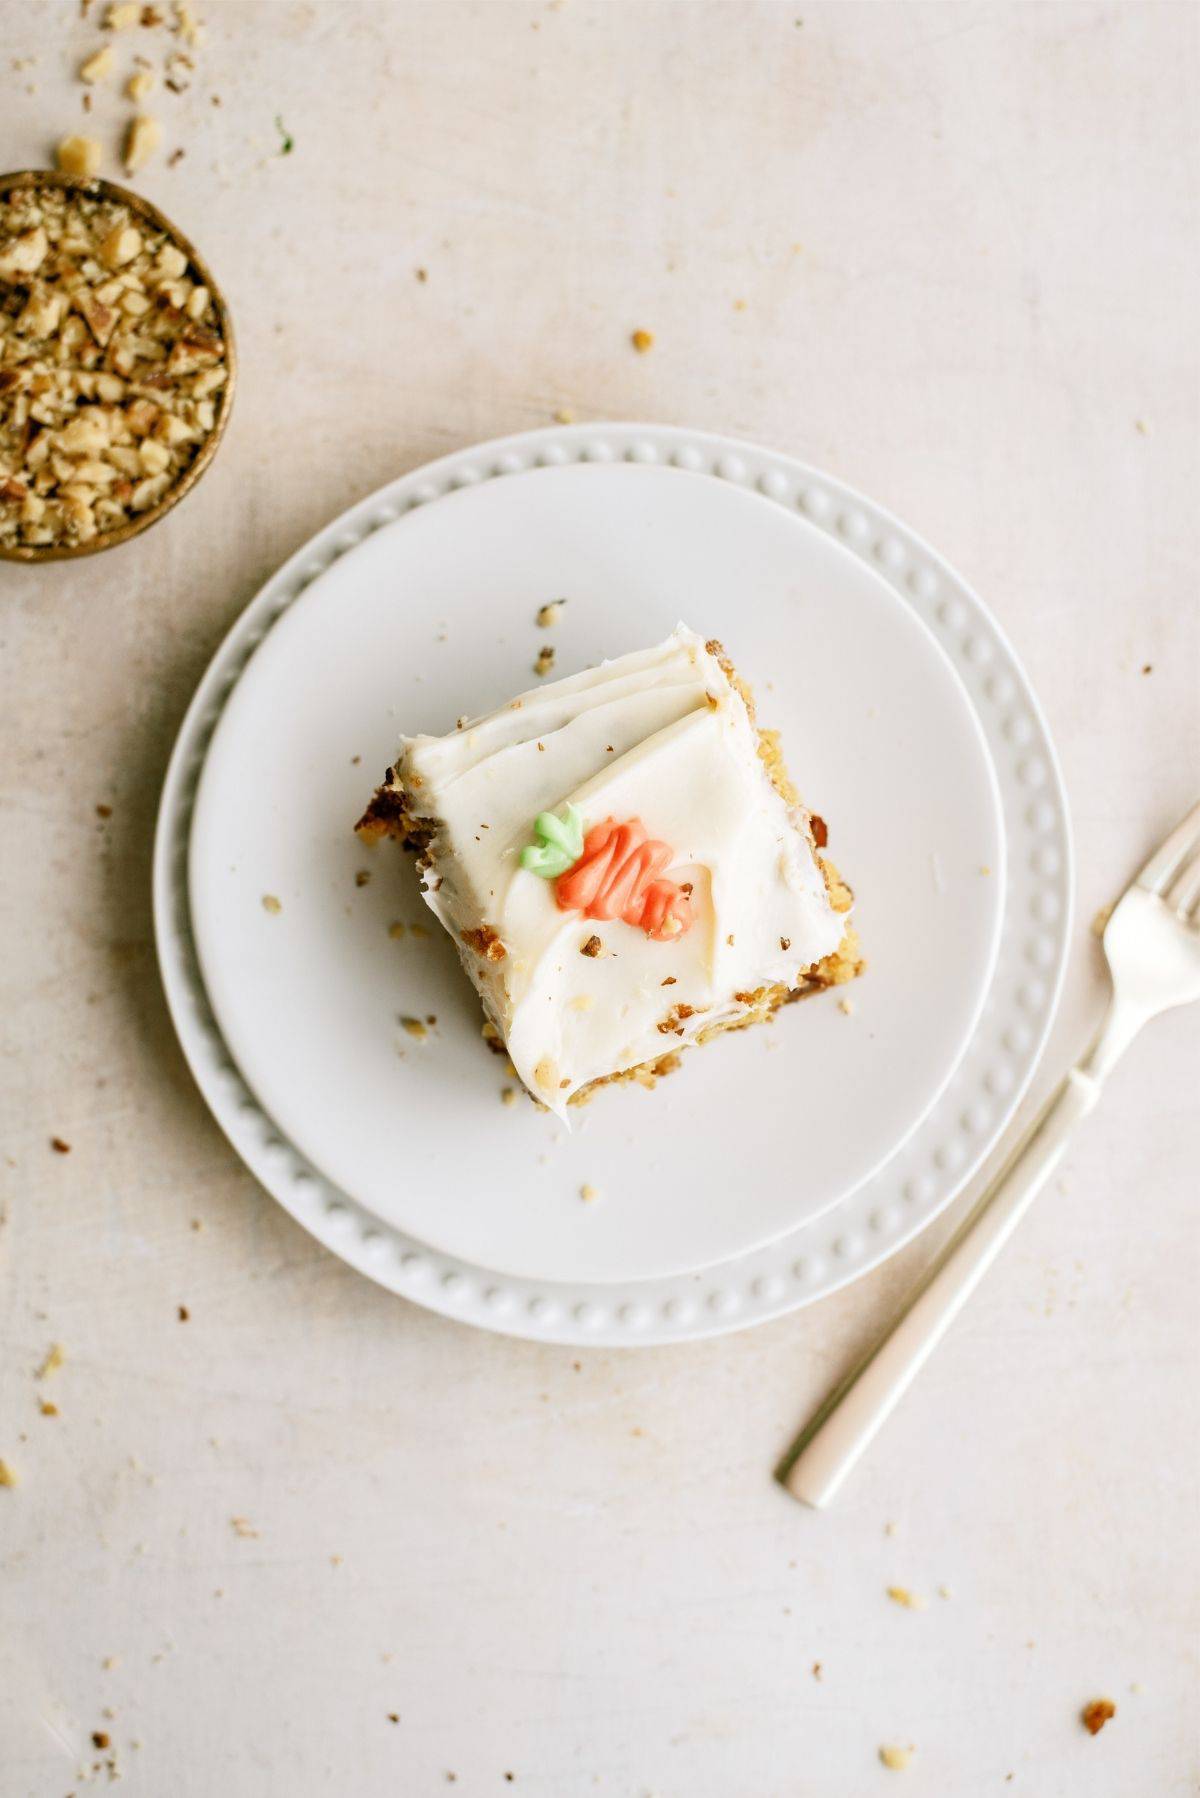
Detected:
[{"left": 155, "top": 424, "right": 1072, "bottom": 1347}]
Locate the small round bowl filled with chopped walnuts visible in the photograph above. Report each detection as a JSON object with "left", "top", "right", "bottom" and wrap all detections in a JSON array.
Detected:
[{"left": 0, "top": 173, "right": 237, "bottom": 563}]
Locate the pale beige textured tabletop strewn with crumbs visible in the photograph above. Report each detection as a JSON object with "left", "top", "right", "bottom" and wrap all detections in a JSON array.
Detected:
[{"left": 0, "top": 0, "right": 1200, "bottom": 1798}]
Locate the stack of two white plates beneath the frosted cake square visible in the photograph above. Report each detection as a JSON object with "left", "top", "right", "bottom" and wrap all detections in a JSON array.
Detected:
[{"left": 157, "top": 426, "right": 1069, "bottom": 1341}]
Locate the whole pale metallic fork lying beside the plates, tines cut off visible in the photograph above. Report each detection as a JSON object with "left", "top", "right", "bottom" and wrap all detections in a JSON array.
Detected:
[{"left": 781, "top": 806, "right": 1200, "bottom": 1509}]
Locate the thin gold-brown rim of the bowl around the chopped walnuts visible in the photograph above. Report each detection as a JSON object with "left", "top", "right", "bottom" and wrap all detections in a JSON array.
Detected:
[{"left": 0, "top": 169, "right": 237, "bottom": 563}]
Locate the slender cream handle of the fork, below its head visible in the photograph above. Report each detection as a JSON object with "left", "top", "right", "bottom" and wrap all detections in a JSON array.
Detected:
[{"left": 783, "top": 1068, "right": 1099, "bottom": 1509}]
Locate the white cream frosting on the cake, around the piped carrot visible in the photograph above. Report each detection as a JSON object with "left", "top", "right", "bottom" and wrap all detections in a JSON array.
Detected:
[{"left": 396, "top": 624, "right": 846, "bottom": 1118}]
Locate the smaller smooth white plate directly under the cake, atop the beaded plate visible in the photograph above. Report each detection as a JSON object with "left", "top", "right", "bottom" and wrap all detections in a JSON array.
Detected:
[{"left": 191, "top": 462, "right": 1004, "bottom": 1282}]
